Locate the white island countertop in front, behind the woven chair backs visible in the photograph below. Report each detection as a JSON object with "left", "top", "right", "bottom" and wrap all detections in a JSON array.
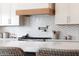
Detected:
[{"left": 0, "top": 40, "right": 79, "bottom": 52}]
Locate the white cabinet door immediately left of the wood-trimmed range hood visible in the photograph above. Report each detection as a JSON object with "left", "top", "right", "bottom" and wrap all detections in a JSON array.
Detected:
[{"left": 10, "top": 4, "right": 19, "bottom": 26}]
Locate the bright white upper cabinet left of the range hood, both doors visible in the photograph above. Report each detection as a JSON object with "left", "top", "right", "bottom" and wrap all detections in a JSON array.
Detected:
[{"left": 0, "top": 3, "right": 19, "bottom": 26}]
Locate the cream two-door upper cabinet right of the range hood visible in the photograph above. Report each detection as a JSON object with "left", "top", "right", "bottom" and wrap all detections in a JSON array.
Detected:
[{"left": 55, "top": 3, "right": 79, "bottom": 24}]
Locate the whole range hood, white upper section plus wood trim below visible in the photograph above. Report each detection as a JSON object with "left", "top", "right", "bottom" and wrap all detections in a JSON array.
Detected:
[{"left": 16, "top": 3, "right": 55, "bottom": 15}]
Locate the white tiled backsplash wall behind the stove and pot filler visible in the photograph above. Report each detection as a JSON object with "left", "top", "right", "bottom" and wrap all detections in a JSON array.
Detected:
[{"left": 0, "top": 15, "right": 79, "bottom": 40}]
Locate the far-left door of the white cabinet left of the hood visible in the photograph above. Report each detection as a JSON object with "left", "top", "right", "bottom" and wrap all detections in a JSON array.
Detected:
[{"left": 1, "top": 3, "right": 11, "bottom": 26}]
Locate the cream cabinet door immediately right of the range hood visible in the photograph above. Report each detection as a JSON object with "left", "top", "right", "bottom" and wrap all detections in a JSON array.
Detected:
[{"left": 55, "top": 3, "right": 68, "bottom": 24}]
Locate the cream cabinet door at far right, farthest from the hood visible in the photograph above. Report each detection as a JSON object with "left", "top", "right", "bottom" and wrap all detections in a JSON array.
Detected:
[{"left": 70, "top": 3, "right": 79, "bottom": 24}]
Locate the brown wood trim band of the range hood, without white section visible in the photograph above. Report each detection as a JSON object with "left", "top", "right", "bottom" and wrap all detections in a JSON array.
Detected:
[{"left": 16, "top": 3, "right": 55, "bottom": 15}]
